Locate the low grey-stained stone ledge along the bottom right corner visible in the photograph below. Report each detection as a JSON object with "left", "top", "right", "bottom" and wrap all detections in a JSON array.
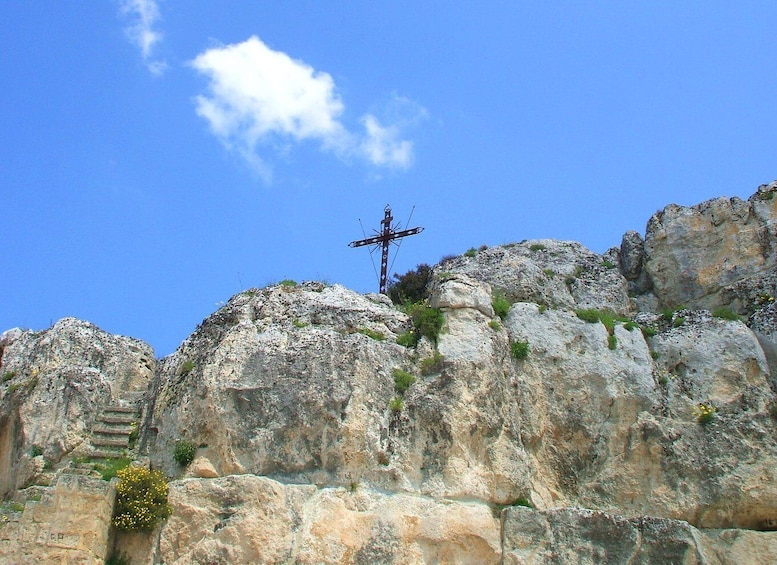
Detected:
[{"left": 502, "top": 507, "right": 777, "bottom": 565}]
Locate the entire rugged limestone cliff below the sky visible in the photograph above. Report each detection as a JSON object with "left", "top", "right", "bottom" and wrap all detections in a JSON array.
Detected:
[{"left": 0, "top": 182, "right": 777, "bottom": 564}]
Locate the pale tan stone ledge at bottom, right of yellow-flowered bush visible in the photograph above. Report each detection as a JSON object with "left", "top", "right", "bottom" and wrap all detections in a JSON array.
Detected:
[{"left": 157, "top": 475, "right": 501, "bottom": 565}]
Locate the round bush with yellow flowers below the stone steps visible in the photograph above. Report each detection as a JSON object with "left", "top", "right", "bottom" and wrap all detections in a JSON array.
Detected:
[{"left": 113, "top": 465, "right": 172, "bottom": 530}]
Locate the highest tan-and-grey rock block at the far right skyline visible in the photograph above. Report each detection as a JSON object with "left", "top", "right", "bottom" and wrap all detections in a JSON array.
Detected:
[{"left": 644, "top": 181, "right": 777, "bottom": 309}]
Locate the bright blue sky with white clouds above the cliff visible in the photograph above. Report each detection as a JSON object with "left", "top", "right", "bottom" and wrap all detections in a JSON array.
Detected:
[{"left": 0, "top": 0, "right": 777, "bottom": 356}]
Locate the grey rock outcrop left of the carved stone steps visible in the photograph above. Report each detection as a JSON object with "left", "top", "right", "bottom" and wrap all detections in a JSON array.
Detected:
[{"left": 0, "top": 318, "right": 156, "bottom": 493}]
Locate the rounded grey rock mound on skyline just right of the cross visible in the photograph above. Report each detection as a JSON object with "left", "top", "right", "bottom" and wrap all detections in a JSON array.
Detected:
[{"left": 434, "top": 239, "right": 631, "bottom": 313}]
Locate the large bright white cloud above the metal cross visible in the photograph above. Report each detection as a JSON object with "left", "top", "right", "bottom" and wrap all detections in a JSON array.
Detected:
[{"left": 191, "top": 36, "right": 422, "bottom": 182}]
